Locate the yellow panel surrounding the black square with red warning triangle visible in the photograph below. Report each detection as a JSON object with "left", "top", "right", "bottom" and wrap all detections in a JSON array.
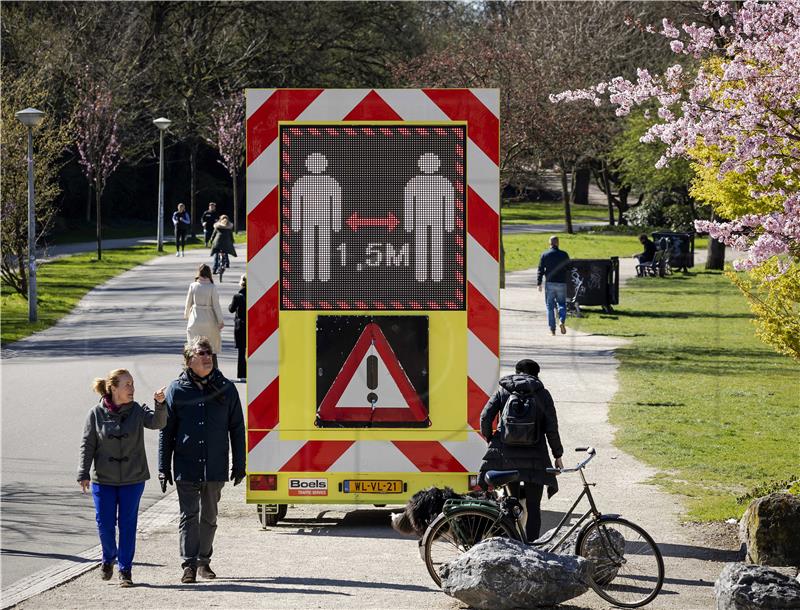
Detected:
[{"left": 278, "top": 311, "right": 467, "bottom": 441}]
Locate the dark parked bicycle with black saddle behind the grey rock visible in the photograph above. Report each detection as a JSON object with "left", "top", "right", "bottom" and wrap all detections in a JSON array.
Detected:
[{"left": 420, "top": 447, "right": 664, "bottom": 608}]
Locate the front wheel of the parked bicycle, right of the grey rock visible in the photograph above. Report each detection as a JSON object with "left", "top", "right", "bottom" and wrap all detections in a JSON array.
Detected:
[{"left": 576, "top": 517, "right": 664, "bottom": 608}]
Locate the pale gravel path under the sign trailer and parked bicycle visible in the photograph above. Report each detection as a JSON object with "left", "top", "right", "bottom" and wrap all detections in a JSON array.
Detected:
[{"left": 4, "top": 243, "right": 736, "bottom": 610}]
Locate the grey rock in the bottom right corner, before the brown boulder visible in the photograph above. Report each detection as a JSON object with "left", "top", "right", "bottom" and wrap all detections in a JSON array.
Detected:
[{"left": 714, "top": 563, "right": 800, "bottom": 610}]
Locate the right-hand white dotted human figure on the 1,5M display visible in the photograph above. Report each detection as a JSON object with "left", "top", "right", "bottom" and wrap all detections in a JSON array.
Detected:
[{"left": 403, "top": 153, "right": 455, "bottom": 282}]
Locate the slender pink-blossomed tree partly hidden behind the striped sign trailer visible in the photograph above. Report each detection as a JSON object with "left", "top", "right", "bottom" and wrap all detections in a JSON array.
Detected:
[{"left": 206, "top": 93, "right": 244, "bottom": 232}]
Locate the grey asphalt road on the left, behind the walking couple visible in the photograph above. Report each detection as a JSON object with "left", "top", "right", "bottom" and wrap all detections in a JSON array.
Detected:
[{"left": 0, "top": 244, "right": 245, "bottom": 588}]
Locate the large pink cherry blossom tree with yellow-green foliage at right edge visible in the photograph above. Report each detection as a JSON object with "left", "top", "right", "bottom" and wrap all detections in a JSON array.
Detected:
[{"left": 551, "top": 0, "right": 800, "bottom": 358}]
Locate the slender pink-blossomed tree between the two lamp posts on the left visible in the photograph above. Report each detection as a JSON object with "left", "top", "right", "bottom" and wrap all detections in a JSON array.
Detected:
[{"left": 74, "top": 71, "right": 122, "bottom": 260}]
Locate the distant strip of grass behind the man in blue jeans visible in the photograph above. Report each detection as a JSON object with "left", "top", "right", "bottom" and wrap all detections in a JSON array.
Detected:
[{"left": 503, "top": 232, "right": 708, "bottom": 271}]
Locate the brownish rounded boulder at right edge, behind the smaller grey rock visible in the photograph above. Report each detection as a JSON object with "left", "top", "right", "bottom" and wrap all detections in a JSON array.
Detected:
[{"left": 739, "top": 493, "right": 800, "bottom": 566}]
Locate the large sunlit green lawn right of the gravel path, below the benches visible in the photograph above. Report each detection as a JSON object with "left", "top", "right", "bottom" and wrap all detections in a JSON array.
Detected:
[{"left": 565, "top": 270, "right": 800, "bottom": 521}]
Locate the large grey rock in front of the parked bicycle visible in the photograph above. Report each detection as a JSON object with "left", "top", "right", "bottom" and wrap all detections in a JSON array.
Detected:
[{"left": 440, "top": 538, "right": 592, "bottom": 610}]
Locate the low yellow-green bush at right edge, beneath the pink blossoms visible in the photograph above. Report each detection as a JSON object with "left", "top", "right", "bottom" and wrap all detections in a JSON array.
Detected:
[{"left": 728, "top": 261, "right": 800, "bottom": 360}]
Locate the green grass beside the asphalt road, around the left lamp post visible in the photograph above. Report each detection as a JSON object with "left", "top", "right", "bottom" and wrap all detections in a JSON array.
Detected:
[{"left": 0, "top": 242, "right": 204, "bottom": 345}]
